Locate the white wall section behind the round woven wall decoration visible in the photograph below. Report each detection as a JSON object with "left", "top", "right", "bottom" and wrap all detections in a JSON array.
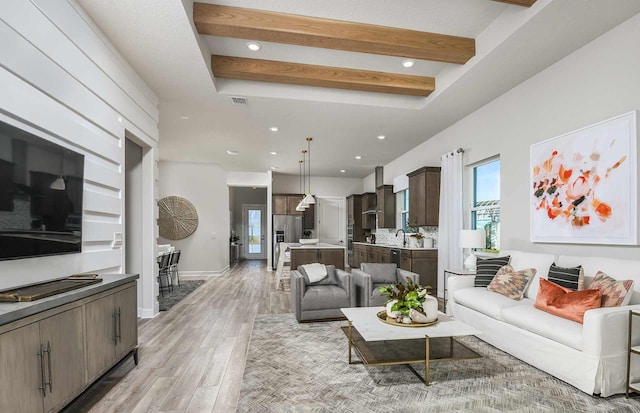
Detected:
[{"left": 158, "top": 161, "right": 229, "bottom": 274}]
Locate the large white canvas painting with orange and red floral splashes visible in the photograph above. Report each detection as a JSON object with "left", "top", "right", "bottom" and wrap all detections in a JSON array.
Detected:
[{"left": 530, "top": 112, "right": 637, "bottom": 245}]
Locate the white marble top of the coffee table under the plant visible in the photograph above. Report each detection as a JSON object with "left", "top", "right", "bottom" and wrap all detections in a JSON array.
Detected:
[{"left": 340, "top": 307, "right": 481, "bottom": 341}]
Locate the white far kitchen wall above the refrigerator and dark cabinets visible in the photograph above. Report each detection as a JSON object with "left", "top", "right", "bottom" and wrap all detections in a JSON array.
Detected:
[{"left": 273, "top": 174, "right": 364, "bottom": 197}]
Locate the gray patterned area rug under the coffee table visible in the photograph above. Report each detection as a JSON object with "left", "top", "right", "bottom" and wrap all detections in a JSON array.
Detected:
[{"left": 237, "top": 314, "right": 640, "bottom": 413}]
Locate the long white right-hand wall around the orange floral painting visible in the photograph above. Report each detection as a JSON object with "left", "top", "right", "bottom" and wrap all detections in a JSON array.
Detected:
[{"left": 380, "top": 15, "right": 640, "bottom": 259}]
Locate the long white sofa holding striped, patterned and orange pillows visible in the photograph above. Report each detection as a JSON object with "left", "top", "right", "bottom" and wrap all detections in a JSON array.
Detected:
[{"left": 447, "top": 251, "right": 640, "bottom": 397}]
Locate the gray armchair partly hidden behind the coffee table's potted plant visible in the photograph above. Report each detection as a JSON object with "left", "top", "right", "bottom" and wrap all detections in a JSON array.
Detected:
[{"left": 351, "top": 263, "right": 420, "bottom": 307}]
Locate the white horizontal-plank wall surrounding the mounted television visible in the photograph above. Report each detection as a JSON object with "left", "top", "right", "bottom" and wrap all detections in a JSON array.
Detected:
[{"left": 0, "top": 0, "right": 159, "bottom": 312}]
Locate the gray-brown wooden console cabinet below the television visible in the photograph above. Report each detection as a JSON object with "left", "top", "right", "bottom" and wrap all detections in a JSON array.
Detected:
[{"left": 0, "top": 274, "right": 138, "bottom": 412}]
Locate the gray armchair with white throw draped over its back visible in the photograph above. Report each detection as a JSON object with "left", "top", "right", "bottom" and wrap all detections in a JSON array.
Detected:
[{"left": 291, "top": 265, "right": 356, "bottom": 322}]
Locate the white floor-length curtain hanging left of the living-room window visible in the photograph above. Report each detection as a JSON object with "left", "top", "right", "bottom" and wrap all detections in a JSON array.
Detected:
[{"left": 438, "top": 149, "right": 463, "bottom": 297}]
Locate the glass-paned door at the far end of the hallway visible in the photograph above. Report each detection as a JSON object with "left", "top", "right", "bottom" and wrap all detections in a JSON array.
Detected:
[{"left": 242, "top": 205, "right": 267, "bottom": 260}]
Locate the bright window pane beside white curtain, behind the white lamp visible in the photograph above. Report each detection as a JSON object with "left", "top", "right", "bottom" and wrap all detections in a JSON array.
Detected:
[{"left": 471, "top": 159, "right": 500, "bottom": 251}]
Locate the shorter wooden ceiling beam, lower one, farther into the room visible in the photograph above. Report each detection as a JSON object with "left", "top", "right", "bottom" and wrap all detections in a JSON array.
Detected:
[{"left": 211, "top": 55, "right": 435, "bottom": 96}]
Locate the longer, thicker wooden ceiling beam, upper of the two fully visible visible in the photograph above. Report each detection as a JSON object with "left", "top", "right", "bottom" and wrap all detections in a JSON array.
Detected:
[{"left": 193, "top": 3, "right": 475, "bottom": 64}]
